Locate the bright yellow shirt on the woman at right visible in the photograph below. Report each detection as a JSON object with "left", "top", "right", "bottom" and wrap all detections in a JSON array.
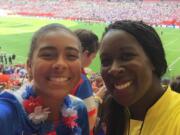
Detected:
[{"left": 129, "top": 87, "right": 180, "bottom": 135}]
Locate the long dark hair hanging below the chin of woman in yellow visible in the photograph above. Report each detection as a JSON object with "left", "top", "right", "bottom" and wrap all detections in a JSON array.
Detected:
[{"left": 95, "top": 95, "right": 127, "bottom": 135}]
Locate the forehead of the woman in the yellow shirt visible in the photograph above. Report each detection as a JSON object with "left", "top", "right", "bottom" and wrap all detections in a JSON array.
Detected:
[{"left": 100, "top": 30, "right": 143, "bottom": 53}]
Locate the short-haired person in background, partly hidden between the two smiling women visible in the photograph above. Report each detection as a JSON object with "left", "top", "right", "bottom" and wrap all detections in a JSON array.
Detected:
[{"left": 72, "top": 29, "right": 105, "bottom": 135}]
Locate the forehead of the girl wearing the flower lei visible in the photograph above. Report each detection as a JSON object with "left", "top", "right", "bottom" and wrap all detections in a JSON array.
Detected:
[{"left": 37, "top": 30, "right": 80, "bottom": 50}]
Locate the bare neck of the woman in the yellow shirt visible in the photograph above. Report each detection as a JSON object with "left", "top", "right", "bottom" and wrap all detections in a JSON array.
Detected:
[{"left": 129, "top": 79, "right": 165, "bottom": 121}]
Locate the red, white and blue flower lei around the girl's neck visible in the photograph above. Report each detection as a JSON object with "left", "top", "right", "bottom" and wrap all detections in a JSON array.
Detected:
[{"left": 21, "top": 85, "right": 81, "bottom": 135}]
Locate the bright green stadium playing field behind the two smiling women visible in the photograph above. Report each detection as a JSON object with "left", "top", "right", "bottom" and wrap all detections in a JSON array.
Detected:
[{"left": 0, "top": 16, "right": 180, "bottom": 77}]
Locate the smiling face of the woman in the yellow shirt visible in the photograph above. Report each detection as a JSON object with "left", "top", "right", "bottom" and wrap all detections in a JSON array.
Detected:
[{"left": 100, "top": 30, "right": 153, "bottom": 106}]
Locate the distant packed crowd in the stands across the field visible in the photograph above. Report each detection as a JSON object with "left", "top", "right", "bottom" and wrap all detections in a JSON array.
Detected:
[{"left": 0, "top": 0, "right": 180, "bottom": 24}]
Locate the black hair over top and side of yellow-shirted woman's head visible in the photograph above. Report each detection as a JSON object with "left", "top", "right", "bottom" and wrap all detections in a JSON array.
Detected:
[{"left": 103, "top": 20, "right": 167, "bottom": 78}]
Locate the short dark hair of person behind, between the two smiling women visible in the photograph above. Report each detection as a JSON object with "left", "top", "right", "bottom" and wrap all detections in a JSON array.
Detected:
[{"left": 74, "top": 29, "right": 99, "bottom": 54}]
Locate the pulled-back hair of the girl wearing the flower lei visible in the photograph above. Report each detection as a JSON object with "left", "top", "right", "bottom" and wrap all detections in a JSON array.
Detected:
[{"left": 28, "top": 23, "right": 77, "bottom": 59}]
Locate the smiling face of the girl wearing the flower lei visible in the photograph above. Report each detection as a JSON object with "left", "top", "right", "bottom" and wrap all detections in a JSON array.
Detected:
[{"left": 28, "top": 30, "right": 81, "bottom": 98}]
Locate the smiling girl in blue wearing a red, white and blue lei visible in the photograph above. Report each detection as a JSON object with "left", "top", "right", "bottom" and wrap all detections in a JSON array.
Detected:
[{"left": 0, "top": 24, "right": 89, "bottom": 135}]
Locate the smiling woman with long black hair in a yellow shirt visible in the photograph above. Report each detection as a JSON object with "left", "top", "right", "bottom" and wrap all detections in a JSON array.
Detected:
[{"left": 97, "top": 20, "right": 180, "bottom": 135}]
